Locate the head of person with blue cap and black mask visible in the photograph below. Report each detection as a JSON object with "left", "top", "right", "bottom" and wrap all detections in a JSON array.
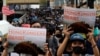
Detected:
[{"left": 70, "top": 33, "right": 85, "bottom": 54}]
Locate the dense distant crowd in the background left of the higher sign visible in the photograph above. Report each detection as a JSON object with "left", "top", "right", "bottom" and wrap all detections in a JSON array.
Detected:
[{"left": 11, "top": 7, "right": 63, "bottom": 26}]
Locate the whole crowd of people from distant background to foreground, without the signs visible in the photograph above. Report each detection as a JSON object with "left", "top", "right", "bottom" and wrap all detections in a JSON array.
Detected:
[{"left": 1, "top": 8, "right": 100, "bottom": 56}]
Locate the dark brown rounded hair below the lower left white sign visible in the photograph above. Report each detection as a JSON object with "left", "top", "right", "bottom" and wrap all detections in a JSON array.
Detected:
[{"left": 14, "top": 42, "right": 38, "bottom": 56}]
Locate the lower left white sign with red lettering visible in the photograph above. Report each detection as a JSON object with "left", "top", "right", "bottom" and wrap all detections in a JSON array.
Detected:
[{"left": 7, "top": 27, "right": 46, "bottom": 48}]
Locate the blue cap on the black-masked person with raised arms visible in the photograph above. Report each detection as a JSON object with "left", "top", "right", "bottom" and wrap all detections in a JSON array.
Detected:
[{"left": 70, "top": 33, "right": 85, "bottom": 41}]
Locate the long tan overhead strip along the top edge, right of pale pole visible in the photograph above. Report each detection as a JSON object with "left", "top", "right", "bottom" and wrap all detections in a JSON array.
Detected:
[{"left": 7, "top": 0, "right": 40, "bottom": 4}]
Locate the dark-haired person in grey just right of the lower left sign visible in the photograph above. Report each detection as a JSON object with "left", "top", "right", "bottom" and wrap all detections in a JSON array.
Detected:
[{"left": 46, "top": 24, "right": 59, "bottom": 56}]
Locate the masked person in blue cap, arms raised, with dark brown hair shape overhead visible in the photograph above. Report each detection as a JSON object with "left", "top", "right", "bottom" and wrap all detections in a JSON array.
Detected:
[{"left": 57, "top": 22, "right": 99, "bottom": 56}]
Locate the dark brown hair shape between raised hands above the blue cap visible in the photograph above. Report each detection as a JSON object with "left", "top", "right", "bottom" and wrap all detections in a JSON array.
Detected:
[{"left": 68, "top": 22, "right": 91, "bottom": 34}]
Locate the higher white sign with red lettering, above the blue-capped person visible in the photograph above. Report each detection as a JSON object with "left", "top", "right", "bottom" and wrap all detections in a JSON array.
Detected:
[{"left": 63, "top": 6, "right": 96, "bottom": 26}]
